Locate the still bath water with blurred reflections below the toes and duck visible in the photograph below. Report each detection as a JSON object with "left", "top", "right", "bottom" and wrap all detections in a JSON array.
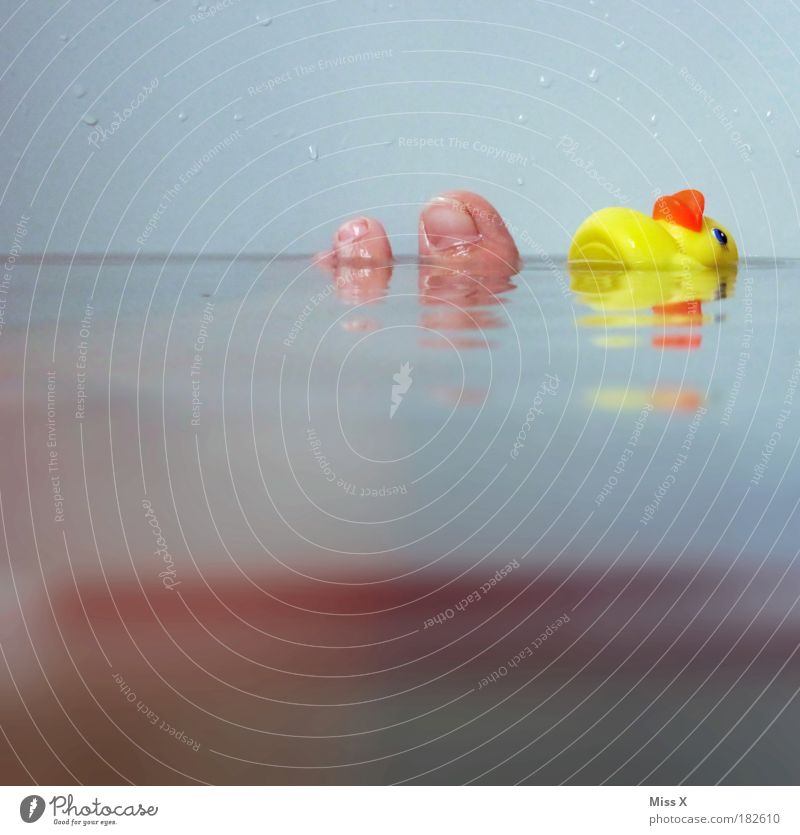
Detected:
[{"left": 0, "top": 256, "right": 800, "bottom": 784}]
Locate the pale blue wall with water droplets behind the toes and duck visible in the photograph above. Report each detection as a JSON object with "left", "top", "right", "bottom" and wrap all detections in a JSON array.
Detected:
[{"left": 0, "top": 0, "right": 800, "bottom": 255}]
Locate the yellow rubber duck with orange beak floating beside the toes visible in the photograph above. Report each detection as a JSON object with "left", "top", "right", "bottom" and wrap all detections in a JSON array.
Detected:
[{"left": 569, "top": 189, "right": 739, "bottom": 270}]
